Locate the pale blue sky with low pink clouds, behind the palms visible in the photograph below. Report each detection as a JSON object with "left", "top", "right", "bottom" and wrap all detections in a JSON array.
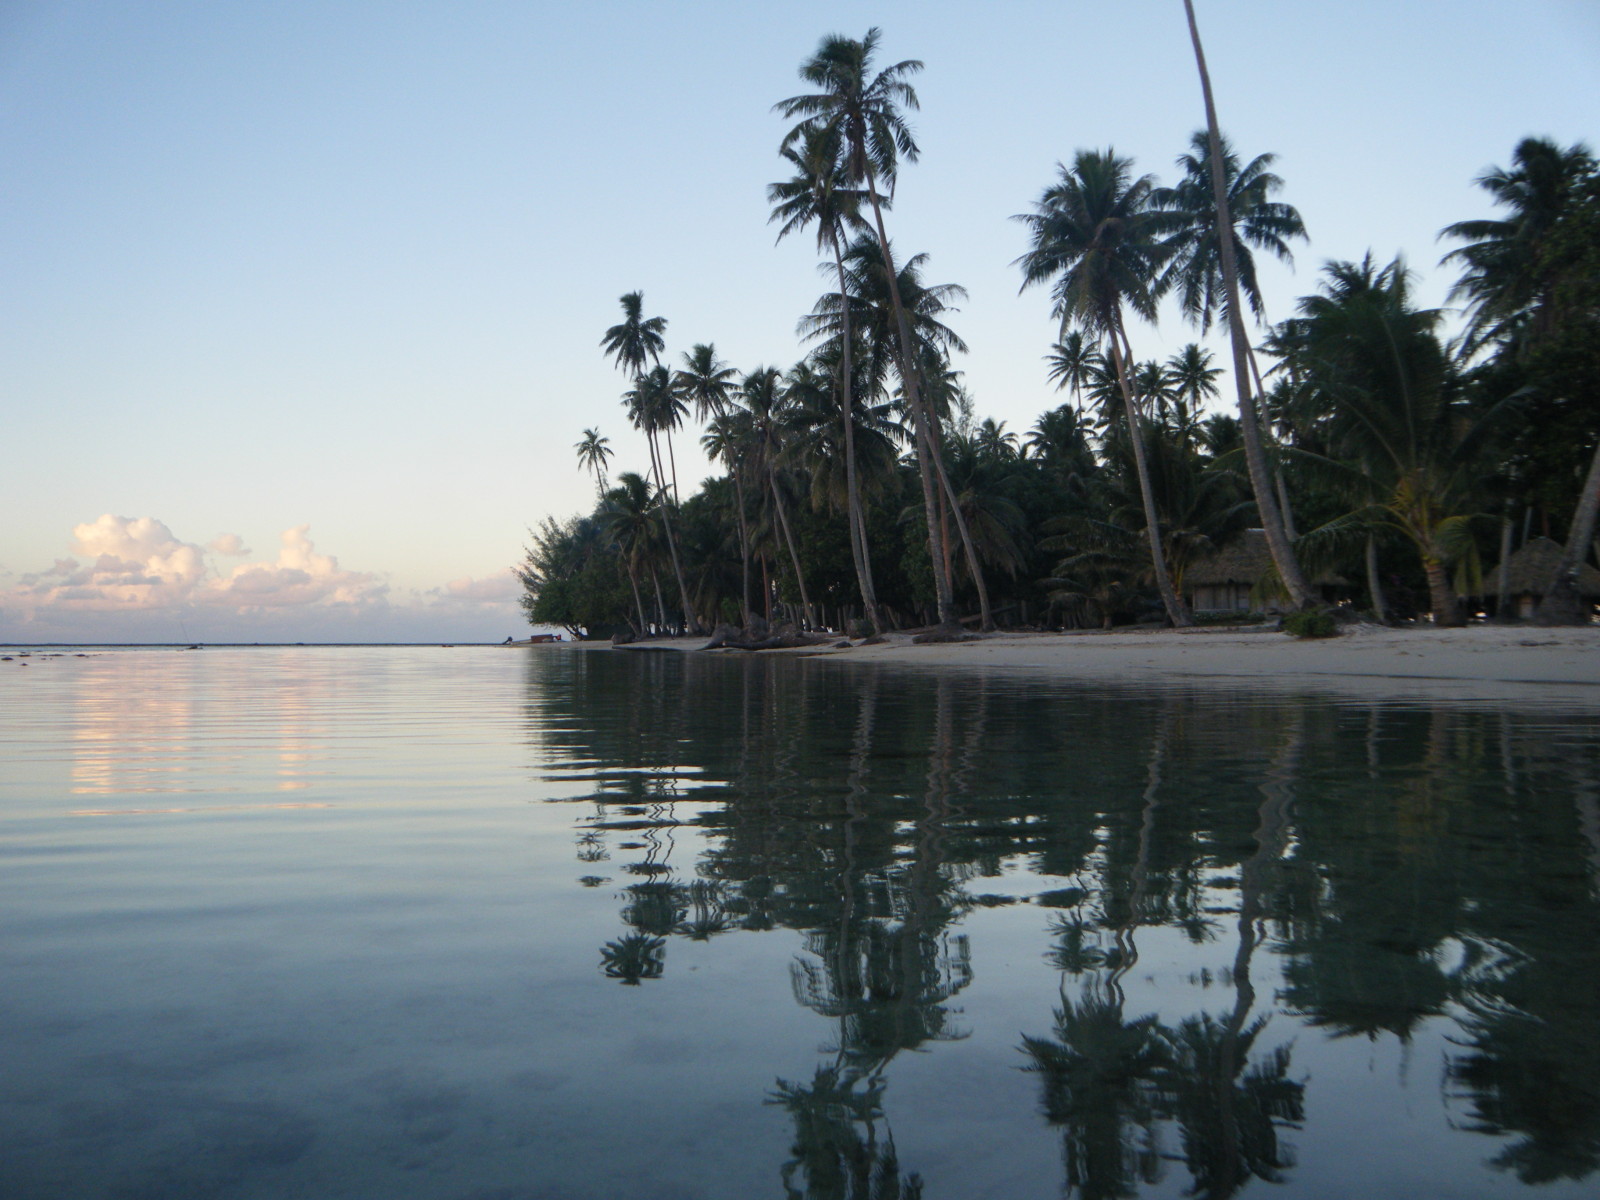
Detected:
[{"left": 0, "top": 0, "right": 1600, "bottom": 642}]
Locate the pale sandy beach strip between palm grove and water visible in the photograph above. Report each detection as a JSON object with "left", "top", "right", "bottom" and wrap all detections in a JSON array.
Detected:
[{"left": 597, "top": 626, "right": 1600, "bottom": 709}]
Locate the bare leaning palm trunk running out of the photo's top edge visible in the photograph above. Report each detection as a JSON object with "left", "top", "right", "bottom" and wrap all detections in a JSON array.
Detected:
[{"left": 1184, "top": 0, "right": 1317, "bottom": 608}]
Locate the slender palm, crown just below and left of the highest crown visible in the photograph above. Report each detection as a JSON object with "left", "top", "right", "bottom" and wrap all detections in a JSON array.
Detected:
[{"left": 766, "top": 126, "right": 883, "bottom": 634}]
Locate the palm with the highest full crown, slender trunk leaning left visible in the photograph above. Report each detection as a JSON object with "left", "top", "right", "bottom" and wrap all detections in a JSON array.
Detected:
[{"left": 773, "top": 27, "right": 957, "bottom": 627}]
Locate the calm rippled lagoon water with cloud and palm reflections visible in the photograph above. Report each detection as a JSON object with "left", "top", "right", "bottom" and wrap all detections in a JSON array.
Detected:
[{"left": 0, "top": 648, "right": 1600, "bottom": 1200}]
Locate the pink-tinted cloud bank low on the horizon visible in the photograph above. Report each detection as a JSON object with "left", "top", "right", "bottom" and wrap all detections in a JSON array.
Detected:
[{"left": 0, "top": 512, "right": 526, "bottom": 642}]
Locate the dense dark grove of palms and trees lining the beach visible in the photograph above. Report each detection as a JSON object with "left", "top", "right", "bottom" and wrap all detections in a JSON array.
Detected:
[{"left": 518, "top": 23, "right": 1600, "bottom": 637}]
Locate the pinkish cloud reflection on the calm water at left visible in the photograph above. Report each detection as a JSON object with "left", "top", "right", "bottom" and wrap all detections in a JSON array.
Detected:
[{"left": 70, "top": 653, "right": 323, "bottom": 793}]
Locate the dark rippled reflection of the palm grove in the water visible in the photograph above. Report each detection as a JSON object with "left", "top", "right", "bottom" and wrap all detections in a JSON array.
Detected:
[{"left": 524, "top": 654, "right": 1600, "bottom": 1197}]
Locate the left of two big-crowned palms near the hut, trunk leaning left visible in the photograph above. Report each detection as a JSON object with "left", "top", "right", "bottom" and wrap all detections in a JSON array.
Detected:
[{"left": 1016, "top": 150, "right": 1194, "bottom": 626}]
